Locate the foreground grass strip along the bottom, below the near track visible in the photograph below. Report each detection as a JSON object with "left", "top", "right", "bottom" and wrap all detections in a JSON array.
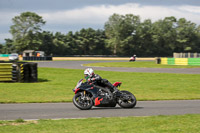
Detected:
[{"left": 0, "top": 114, "right": 200, "bottom": 133}]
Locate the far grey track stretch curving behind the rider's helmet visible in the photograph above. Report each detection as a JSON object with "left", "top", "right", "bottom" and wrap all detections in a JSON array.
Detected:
[{"left": 38, "top": 61, "right": 200, "bottom": 74}]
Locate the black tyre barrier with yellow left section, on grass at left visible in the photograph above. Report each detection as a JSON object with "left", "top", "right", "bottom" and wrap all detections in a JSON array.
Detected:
[{"left": 0, "top": 62, "right": 38, "bottom": 83}]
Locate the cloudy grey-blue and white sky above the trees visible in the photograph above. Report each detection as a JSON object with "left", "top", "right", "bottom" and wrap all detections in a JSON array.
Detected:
[{"left": 0, "top": 0, "right": 200, "bottom": 43}]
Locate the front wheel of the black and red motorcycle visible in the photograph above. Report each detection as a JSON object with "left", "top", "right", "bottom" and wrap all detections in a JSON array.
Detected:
[{"left": 73, "top": 92, "right": 93, "bottom": 110}]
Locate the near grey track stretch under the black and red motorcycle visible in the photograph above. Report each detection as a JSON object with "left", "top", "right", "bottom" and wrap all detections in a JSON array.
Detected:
[{"left": 0, "top": 100, "right": 200, "bottom": 120}]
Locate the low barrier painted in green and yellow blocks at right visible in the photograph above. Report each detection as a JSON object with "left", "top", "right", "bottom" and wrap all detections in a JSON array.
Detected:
[{"left": 161, "top": 58, "right": 200, "bottom": 66}]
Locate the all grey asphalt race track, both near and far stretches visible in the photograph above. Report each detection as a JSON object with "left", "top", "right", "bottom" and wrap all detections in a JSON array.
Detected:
[{"left": 0, "top": 61, "right": 200, "bottom": 120}]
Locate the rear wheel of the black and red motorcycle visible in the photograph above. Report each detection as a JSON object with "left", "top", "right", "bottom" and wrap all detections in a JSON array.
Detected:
[{"left": 118, "top": 91, "right": 137, "bottom": 108}]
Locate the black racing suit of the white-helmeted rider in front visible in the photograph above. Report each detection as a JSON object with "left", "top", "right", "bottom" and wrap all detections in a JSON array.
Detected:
[{"left": 87, "top": 74, "right": 115, "bottom": 92}]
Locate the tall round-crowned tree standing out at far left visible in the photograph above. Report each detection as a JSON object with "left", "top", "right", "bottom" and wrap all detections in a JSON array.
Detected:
[{"left": 10, "top": 12, "right": 45, "bottom": 52}]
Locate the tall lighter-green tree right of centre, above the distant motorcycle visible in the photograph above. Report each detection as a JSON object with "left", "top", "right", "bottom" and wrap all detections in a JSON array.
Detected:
[{"left": 104, "top": 14, "right": 140, "bottom": 55}]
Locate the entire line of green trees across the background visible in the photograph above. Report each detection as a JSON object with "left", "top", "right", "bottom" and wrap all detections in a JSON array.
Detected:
[{"left": 0, "top": 12, "right": 200, "bottom": 57}]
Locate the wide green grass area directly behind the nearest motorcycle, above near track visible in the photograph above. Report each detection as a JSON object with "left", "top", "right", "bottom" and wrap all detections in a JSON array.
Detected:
[{"left": 0, "top": 68, "right": 200, "bottom": 103}]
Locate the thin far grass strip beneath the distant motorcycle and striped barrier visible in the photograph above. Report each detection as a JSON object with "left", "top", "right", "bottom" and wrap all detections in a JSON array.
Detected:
[{"left": 84, "top": 61, "right": 200, "bottom": 68}]
